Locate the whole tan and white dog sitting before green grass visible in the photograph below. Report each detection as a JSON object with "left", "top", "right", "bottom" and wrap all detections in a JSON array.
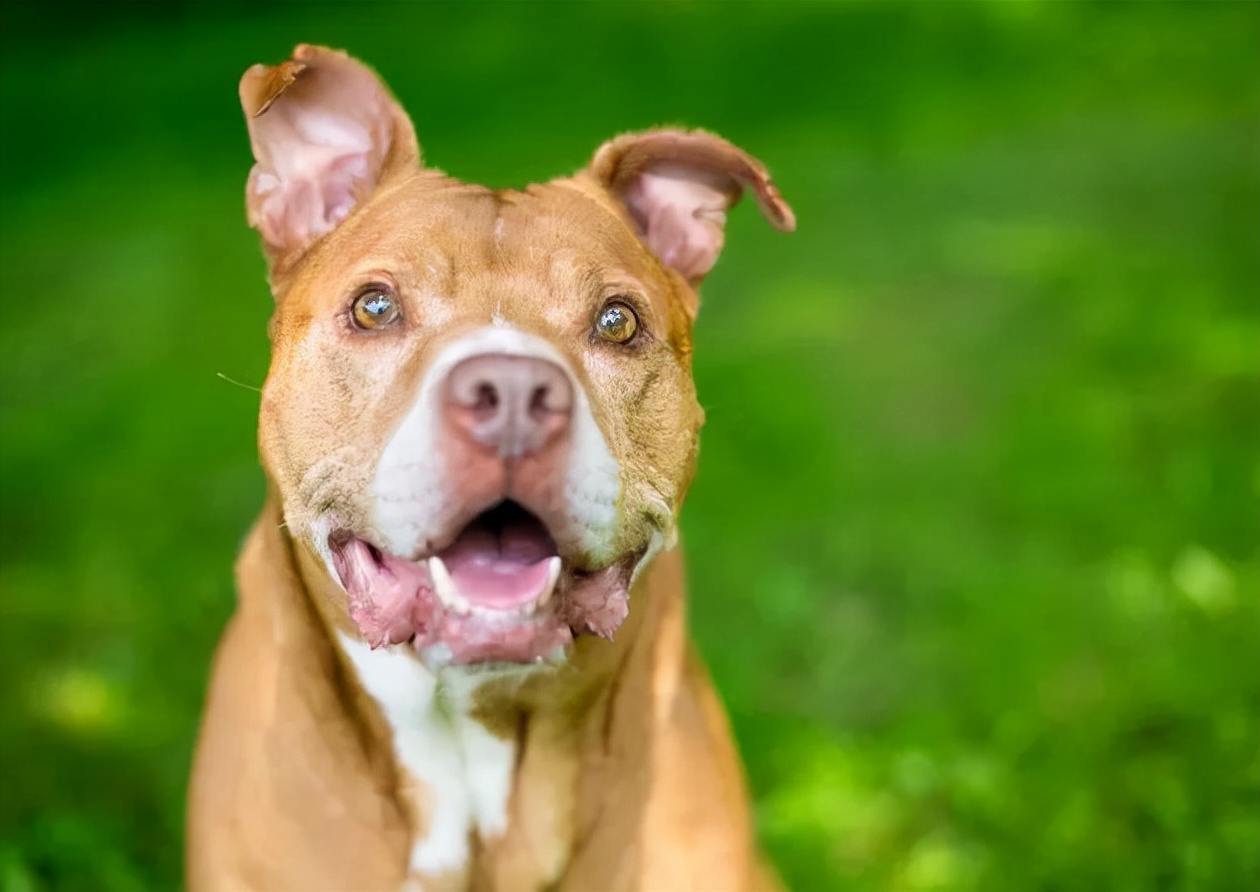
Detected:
[{"left": 186, "top": 45, "right": 794, "bottom": 892}]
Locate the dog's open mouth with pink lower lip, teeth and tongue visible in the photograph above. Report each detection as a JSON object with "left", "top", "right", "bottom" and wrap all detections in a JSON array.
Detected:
[{"left": 328, "top": 501, "right": 644, "bottom": 666}]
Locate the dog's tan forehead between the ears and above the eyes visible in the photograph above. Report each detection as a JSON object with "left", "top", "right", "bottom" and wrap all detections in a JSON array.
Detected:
[{"left": 278, "top": 170, "right": 689, "bottom": 354}]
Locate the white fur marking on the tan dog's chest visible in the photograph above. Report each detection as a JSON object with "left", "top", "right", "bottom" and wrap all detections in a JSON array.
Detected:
[{"left": 338, "top": 631, "right": 517, "bottom": 873}]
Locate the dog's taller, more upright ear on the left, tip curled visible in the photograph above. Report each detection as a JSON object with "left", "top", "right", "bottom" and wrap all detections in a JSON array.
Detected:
[{"left": 241, "top": 44, "right": 420, "bottom": 267}]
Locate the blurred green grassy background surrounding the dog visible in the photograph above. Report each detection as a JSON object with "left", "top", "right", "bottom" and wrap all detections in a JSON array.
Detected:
[{"left": 0, "top": 3, "right": 1260, "bottom": 892}]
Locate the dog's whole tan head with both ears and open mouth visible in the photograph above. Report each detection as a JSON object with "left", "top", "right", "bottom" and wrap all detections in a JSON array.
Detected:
[{"left": 241, "top": 47, "right": 793, "bottom": 665}]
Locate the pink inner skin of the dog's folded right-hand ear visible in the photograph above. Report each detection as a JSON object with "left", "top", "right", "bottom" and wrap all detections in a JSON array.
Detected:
[{"left": 622, "top": 164, "right": 738, "bottom": 281}]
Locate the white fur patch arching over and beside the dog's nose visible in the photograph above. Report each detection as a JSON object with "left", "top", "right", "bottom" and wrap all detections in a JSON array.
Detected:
[{"left": 373, "top": 324, "right": 621, "bottom": 561}]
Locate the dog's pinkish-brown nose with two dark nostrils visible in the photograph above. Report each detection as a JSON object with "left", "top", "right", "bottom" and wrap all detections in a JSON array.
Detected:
[{"left": 445, "top": 353, "right": 573, "bottom": 457}]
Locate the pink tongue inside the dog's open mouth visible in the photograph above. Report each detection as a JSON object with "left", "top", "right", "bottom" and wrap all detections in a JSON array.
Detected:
[{"left": 440, "top": 527, "right": 551, "bottom": 610}]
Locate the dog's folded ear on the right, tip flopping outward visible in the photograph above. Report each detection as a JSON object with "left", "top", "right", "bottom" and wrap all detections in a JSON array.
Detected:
[{"left": 586, "top": 130, "right": 796, "bottom": 285}]
